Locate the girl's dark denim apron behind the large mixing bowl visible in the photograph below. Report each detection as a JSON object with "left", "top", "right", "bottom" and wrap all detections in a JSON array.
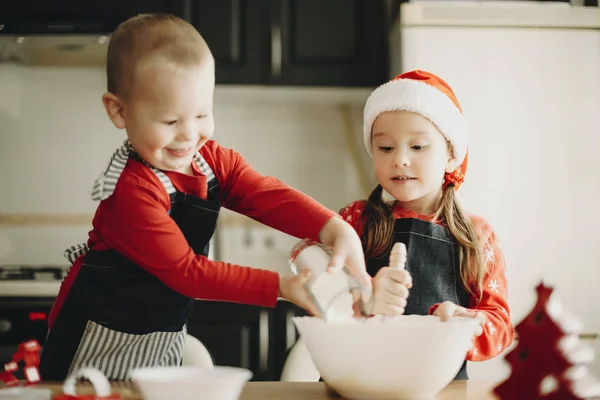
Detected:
[{"left": 367, "top": 218, "right": 469, "bottom": 379}]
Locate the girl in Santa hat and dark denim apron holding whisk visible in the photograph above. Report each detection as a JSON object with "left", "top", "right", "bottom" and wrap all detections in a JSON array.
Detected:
[{"left": 340, "top": 70, "right": 514, "bottom": 379}]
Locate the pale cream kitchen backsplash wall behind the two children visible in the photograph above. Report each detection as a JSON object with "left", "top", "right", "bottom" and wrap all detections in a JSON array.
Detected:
[{"left": 0, "top": 65, "right": 372, "bottom": 268}]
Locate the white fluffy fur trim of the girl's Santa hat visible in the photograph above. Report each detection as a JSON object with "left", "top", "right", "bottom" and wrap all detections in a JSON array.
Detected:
[{"left": 363, "top": 79, "right": 469, "bottom": 166}]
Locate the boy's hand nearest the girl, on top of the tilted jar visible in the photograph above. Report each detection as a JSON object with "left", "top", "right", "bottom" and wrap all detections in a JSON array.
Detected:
[{"left": 319, "top": 217, "right": 372, "bottom": 292}]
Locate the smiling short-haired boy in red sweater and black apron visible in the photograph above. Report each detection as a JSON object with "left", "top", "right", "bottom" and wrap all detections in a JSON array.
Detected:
[{"left": 40, "top": 15, "right": 371, "bottom": 380}]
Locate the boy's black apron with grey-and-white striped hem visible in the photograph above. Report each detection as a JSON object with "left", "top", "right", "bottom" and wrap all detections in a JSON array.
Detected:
[{"left": 40, "top": 157, "right": 220, "bottom": 381}]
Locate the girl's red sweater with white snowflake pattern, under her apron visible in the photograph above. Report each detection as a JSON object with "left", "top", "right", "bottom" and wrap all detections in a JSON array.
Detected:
[{"left": 340, "top": 201, "right": 514, "bottom": 361}]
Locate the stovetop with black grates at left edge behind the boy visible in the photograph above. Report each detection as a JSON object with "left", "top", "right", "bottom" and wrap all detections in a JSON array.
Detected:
[{"left": 0, "top": 265, "right": 67, "bottom": 297}]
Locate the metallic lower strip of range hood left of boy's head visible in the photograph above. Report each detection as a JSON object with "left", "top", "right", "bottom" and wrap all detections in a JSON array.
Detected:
[{"left": 0, "top": 34, "right": 110, "bottom": 66}]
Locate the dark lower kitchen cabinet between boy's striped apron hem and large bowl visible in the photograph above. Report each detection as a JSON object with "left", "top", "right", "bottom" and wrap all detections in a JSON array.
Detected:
[{"left": 188, "top": 300, "right": 306, "bottom": 381}]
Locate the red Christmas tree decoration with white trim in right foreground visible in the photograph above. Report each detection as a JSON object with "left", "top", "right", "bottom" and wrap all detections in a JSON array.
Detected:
[{"left": 494, "top": 283, "right": 600, "bottom": 400}]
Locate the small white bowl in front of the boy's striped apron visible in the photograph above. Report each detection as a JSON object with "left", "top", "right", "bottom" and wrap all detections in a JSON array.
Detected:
[{"left": 131, "top": 366, "right": 252, "bottom": 400}]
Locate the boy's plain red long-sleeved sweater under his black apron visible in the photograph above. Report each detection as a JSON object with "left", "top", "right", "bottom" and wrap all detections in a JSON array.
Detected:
[{"left": 48, "top": 141, "right": 337, "bottom": 327}]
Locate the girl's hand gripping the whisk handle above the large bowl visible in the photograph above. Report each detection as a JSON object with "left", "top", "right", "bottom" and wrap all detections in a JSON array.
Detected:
[{"left": 371, "top": 267, "right": 412, "bottom": 316}]
